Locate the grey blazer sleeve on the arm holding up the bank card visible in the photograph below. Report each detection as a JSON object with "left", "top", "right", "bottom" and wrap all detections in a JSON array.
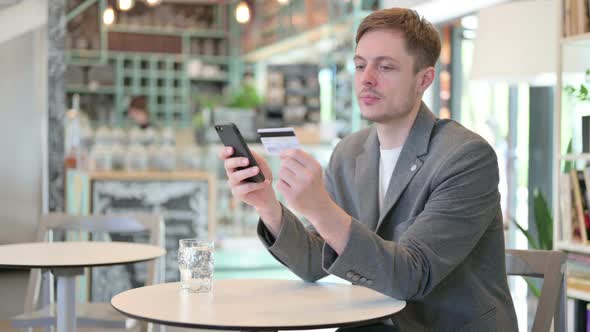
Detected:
[{"left": 322, "top": 139, "right": 500, "bottom": 300}]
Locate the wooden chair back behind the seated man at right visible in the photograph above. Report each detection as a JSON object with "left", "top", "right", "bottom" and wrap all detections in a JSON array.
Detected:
[{"left": 506, "top": 249, "right": 567, "bottom": 332}]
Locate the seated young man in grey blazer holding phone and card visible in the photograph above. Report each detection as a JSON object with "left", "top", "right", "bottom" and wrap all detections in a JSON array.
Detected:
[{"left": 220, "top": 8, "right": 517, "bottom": 331}]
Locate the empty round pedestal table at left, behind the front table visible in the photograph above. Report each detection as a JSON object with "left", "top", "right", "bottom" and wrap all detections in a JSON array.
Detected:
[{"left": 0, "top": 242, "right": 166, "bottom": 332}]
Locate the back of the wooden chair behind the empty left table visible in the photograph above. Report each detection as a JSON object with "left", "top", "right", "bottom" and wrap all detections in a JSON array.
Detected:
[{"left": 25, "top": 213, "right": 165, "bottom": 312}]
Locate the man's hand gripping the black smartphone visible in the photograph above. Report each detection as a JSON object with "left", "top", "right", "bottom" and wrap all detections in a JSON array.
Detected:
[{"left": 219, "top": 147, "right": 283, "bottom": 237}]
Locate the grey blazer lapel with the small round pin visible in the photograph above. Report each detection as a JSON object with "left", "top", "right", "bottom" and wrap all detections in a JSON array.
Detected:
[{"left": 376, "top": 103, "right": 436, "bottom": 230}]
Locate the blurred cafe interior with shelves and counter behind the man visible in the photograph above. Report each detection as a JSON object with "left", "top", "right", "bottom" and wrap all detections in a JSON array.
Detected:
[{"left": 0, "top": 0, "right": 590, "bottom": 330}]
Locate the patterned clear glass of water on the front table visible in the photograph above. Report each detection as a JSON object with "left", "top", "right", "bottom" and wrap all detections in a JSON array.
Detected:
[{"left": 178, "top": 239, "right": 214, "bottom": 293}]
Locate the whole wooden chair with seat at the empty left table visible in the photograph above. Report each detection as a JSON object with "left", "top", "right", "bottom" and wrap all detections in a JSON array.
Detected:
[{"left": 11, "top": 213, "right": 164, "bottom": 330}]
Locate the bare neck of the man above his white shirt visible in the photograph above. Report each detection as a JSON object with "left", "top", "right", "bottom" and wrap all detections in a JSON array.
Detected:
[{"left": 375, "top": 100, "right": 422, "bottom": 149}]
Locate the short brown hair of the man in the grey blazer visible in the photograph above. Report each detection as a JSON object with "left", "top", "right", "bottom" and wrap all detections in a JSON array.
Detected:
[{"left": 356, "top": 8, "right": 440, "bottom": 72}]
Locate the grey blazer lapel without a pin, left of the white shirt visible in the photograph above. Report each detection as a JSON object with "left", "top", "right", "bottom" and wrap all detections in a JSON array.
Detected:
[{"left": 354, "top": 128, "right": 379, "bottom": 230}]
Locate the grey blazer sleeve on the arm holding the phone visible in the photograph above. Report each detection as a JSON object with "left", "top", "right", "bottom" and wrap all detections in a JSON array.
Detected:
[{"left": 257, "top": 155, "right": 342, "bottom": 282}]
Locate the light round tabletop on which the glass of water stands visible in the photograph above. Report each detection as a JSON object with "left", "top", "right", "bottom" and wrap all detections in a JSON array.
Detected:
[{"left": 111, "top": 279, "right": 406, "bottom": 331}]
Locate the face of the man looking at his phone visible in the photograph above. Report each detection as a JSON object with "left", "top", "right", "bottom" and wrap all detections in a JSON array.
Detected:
[{"left": 354, "top": 30, "right": 421, "bottom": 124}]
